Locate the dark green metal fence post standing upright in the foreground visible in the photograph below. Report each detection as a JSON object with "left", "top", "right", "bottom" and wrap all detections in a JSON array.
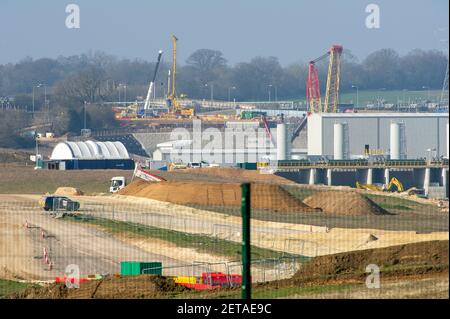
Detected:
[{"left": 241, "top": 183, "right": 251, "bottom": 300}]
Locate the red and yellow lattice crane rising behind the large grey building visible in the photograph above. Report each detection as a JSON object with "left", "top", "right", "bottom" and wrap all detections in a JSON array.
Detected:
[{"left": 306, "top": 45, "right": 343, "bottom": 113}]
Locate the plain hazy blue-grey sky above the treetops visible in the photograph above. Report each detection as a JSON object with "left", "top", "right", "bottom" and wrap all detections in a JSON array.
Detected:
[{"left": 0, "top": 0, "right": 449, "bottom": 64}]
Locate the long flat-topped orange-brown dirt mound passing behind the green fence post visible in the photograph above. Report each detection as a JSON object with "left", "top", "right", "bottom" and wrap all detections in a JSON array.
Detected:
[{"left": 119, "top": 180, "right": 318, "bottom": 212}]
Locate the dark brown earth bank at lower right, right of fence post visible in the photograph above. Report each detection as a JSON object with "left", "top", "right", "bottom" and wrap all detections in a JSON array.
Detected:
[{"left": 294, "top": 240, "right": 449, "bottom": 279}]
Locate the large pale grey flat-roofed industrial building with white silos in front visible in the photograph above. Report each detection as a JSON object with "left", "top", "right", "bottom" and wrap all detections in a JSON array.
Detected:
[{"left": 308, "top": 113, "right": 448, "bottom": 159}]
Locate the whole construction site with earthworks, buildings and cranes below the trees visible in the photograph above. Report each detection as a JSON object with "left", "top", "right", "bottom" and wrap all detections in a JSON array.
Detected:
[{"left": 0, "top": 31, "right": 449, "bottom": 299}]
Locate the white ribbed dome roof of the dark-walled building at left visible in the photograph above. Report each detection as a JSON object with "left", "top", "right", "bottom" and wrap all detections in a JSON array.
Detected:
[{"left": 50, "top": 140, "right": 130, "bottom": 161}]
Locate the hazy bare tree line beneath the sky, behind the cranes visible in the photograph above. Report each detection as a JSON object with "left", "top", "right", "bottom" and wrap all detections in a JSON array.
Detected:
[{"left": 0, "top": 49, "right": 448, "bottom": 146}]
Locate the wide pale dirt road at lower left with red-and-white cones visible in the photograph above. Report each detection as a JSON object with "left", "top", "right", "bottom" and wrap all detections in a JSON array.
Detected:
[{"left": 0, "top": 195, "right": 212, "bottom": 279}]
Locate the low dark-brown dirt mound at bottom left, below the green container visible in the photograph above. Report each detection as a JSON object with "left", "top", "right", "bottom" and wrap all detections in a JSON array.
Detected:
[{"left": 13, "top": 275, "right": 187, "bottom": 299}]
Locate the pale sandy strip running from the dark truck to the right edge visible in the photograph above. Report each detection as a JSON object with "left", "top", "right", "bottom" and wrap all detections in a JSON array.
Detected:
[{"left": 7, "top": 195, "right": 448, "bottom": 256}]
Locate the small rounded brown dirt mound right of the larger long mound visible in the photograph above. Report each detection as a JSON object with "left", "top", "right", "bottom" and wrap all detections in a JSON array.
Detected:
[{"left": 304, "top": 191, "right": 389, "bottom": 216}]
